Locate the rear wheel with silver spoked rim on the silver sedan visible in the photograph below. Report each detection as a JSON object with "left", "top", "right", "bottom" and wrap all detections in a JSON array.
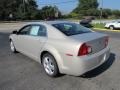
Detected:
[{"left": 42, "top": 53, "right": 59, "bottom": 77}]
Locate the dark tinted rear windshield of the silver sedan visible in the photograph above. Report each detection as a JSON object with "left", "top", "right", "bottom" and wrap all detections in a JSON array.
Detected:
[{"left": 53, "top": 23, "right": 91, "bottom": 36}]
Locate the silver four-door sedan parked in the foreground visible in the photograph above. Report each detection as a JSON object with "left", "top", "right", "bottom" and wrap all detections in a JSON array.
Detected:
[{"left": 9, "top": 21, "right": 110, "bottom": 77}]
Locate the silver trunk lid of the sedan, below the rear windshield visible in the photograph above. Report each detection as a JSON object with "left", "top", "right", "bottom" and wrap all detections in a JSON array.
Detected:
[{"left": 70, "top": 32, "right": 107, "bottom": 54}]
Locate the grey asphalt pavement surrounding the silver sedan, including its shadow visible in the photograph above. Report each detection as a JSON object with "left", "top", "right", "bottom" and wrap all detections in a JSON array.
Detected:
[{"left": 0, "top": 25, "right": 120, "bottom": 90}]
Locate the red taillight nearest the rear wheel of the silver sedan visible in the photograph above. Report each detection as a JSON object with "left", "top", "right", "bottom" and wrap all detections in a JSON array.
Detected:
[{"left": 78, "top": 43, "right": 92, "bottom": 56}]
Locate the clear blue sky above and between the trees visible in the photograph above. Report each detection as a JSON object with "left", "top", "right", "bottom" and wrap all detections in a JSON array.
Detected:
[{"left": 36, "top": 0, "right": 120, "bottom": 14}]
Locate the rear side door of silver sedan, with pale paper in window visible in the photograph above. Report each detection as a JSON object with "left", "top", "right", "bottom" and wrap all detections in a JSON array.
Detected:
[{"left": 25, "top": 25, "right": 47, "bottom": 60}]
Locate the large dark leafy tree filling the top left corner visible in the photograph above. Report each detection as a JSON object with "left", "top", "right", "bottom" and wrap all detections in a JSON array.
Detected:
[{"left": 0, "top": 0, "right": 37, "bottom": 20}]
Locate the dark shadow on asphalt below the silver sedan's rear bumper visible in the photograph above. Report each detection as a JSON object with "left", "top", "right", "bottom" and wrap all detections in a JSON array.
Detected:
[{"left": 81, "top": 53, "right": 115, "bottom": 78}]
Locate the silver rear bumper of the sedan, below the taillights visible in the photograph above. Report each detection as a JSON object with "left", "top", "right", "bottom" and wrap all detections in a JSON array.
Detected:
[{"left": 60, "top": 47, "right": 110, "bottom": 76}]
